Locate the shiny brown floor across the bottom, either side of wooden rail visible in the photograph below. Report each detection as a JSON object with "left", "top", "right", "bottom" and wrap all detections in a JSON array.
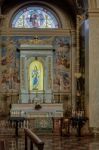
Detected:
[{"left": 0, "top": 135, "right": 99, "bottom": 150}]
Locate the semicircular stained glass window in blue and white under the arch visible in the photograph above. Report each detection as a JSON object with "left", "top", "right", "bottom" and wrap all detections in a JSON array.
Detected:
[{"left": 12, "top": 6, "right": 59, "bottom": 28}]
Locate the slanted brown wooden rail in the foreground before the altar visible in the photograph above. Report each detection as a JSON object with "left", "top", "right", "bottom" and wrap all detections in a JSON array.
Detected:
[{"left": 24, "top": 128, "right": 44, "bottom": 150}]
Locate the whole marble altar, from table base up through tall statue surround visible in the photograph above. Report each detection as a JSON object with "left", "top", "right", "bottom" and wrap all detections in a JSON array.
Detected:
[{"left": 14, "top": 41, "right": 63, "bottom": 132}]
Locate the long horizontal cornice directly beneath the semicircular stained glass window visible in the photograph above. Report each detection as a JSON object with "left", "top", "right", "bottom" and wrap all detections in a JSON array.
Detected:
[{"left": 1, "top": 28, "right": 75, "bottom": 36}]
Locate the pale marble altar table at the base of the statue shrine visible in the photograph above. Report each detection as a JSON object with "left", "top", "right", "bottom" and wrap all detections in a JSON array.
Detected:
[{"left": 10, "top": 103, "right": 63, "bottom": 134}]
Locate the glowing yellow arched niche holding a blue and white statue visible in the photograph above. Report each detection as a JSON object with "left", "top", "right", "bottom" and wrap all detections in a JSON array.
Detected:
[{"left": 29, "top": 60, "right": 43, "bottom": 91}]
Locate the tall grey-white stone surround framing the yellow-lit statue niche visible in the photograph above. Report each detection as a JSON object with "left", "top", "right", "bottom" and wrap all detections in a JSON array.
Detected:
[{"left": 19, "top": 45, "right": 53, "bottom": 103}]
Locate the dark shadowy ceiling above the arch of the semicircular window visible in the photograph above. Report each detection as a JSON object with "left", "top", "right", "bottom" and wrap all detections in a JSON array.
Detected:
[{"left": 0, "top": 0, "right": 88, "bottom": 16}]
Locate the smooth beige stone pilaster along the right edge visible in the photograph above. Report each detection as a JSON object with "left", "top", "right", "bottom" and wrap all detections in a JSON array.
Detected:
[{"left": 89, "top": 9, "right": 99, "bottom": 131}]
